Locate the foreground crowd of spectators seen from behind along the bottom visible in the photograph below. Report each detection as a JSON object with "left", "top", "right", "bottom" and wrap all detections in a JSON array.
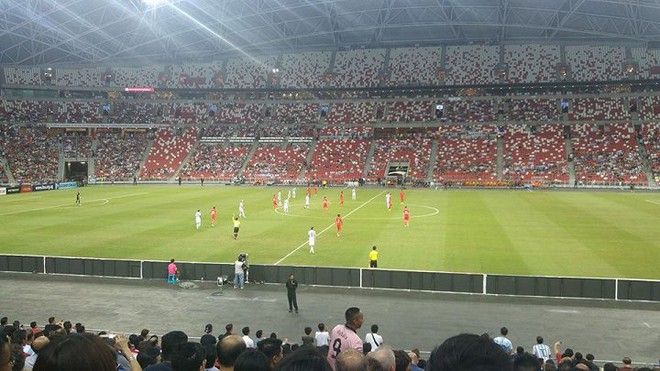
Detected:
[{"left": 0, "top": 307, "right": 660, "bottom": 371}]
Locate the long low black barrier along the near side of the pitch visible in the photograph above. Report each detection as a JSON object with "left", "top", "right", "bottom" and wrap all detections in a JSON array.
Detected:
[{"left": 0, "top": 254, "right": 660, "bottom": 302}]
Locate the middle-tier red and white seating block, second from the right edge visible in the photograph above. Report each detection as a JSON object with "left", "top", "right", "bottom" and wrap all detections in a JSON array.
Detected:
[{"left": 568, "top": 98, "right": 630, "bottom": 121}]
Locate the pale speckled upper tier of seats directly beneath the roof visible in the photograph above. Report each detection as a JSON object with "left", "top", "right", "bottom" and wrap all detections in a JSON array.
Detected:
[{"left": 2, "top": 44, "right": 660, "bottom": 89}]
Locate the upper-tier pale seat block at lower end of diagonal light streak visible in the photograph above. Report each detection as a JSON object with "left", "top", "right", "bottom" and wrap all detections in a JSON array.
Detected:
[{"left": 225, "top": 56, "right": 277, "bottom": 89}]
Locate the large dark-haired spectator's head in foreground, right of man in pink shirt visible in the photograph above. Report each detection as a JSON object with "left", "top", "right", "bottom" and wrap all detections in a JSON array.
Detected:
[{"left": 425, "top": 334, "right": 511, "bottom": 371}]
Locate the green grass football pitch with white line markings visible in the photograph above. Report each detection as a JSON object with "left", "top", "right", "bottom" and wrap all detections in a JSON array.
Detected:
[{"left": 0, "top": 185, "right": 660, "bottom": 279}]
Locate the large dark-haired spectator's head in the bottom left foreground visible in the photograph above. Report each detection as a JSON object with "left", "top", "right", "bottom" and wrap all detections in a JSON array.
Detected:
[{"left": 32, "top": 334, "right": 118, "bottom": 371}]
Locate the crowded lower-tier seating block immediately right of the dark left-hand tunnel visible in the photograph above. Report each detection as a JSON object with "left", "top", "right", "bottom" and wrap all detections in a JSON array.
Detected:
[{"left": 94, "top": 132, "right": 147, "bottom": 180}]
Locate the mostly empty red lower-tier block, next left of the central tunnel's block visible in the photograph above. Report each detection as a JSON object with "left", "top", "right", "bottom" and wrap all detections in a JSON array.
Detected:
[{"left": 305, "top": 139, "right": 370, "bottom": 183}]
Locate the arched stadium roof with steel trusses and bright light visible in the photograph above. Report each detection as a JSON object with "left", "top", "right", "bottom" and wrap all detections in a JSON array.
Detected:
[{"left": 0, "top": 0, "right": 660, "bottom": 65}]
